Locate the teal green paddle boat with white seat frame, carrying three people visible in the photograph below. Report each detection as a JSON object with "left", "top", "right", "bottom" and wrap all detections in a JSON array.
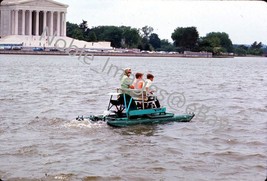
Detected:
[{"left": 76, "top": 89, "right": 195, "bottom": 127}]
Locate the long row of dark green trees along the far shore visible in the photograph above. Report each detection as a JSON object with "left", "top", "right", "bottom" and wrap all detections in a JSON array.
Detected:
[{"left": 67, "top": 20, "right": 263, "bottom": 55}]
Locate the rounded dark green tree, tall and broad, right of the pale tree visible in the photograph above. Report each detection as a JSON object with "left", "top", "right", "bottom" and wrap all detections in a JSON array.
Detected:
[{"left": 171, "top": 27, "right": 199, "bottom": 51}]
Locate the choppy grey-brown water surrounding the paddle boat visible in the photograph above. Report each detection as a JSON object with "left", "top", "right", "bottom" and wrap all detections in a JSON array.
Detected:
[{"left": 0, "top": 55, "right": 267, "bottom": 181}]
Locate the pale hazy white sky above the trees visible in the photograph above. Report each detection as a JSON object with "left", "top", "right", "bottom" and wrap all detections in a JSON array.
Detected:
[{"left": 57, "top": 0, "right": 267, "bottom": 44}]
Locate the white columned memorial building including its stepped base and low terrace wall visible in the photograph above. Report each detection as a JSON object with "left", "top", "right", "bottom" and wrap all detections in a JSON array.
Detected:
[{"left": 0, "top": 0, "right": 112, "bottom": 50}]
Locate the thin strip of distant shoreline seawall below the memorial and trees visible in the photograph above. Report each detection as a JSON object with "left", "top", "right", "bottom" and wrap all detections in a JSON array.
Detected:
[{"left": 0, "top": 50, "right": 222, "bottom": 58}]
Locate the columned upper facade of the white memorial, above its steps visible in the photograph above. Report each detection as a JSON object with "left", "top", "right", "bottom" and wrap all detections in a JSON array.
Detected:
[{"left": 0, "top": 0, "right": 68, "bottom": 37}]
